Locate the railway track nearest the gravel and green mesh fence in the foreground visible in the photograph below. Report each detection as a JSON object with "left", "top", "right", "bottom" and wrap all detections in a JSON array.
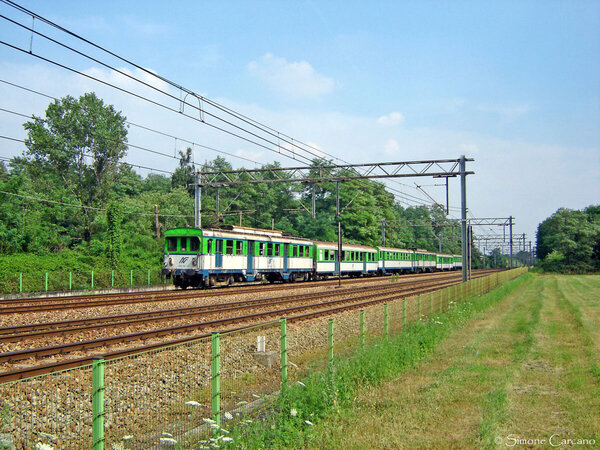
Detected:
[{"left": 0, "top": 273, "right": 494, "bottom": 382}]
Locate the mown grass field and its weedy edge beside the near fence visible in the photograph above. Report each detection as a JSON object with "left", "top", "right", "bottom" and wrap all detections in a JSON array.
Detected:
[{"left": 225, "top": 274, "right": 600, "bottom": 449}]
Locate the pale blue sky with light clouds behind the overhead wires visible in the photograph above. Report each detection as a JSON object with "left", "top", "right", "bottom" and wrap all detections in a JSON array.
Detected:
[{"left": 0, "top": 0, "right": 600, "bottom": 246}]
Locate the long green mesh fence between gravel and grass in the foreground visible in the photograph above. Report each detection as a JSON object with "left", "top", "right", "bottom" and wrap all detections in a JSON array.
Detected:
[{"left": 0, "top": 269, "right": 524, "bottom": 449}]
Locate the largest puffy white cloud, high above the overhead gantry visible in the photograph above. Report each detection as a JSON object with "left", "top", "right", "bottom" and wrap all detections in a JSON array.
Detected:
[{"left": 248, "top": 53, "right": 336, "bottom": 100}]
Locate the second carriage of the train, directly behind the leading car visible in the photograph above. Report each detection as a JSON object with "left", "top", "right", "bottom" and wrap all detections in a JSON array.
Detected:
[{"left": 314, "top": 241, "right": 379, "bottom": 279}]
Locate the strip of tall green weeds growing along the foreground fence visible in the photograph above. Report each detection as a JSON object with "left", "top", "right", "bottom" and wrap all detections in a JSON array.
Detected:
[{"left": 206, "top": 274, "right": 531, "bottom": 448}]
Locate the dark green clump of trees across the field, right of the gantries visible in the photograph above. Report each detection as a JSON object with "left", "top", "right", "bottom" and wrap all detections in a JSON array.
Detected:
[{"left": 537, "top": 205, "right": 600, "bottom": 273}]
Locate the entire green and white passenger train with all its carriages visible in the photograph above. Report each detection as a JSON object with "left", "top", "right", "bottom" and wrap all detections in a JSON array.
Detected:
[{"left": 162, "top": 225, "right": 462, "bottom": 289}]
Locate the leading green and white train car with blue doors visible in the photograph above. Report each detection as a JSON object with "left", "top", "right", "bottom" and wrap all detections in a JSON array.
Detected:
[{"left": 163, "top": 227, "right": 313, "bottom": 289}]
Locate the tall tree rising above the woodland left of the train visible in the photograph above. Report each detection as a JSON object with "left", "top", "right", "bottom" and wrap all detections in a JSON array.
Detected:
[{"left": 24, "top": 93, "right": 127, "bottom": 242}]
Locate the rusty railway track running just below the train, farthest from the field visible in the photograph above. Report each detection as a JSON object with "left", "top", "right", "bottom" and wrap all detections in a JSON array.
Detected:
[{"left": 0, "top": 270, "right": 495, "bottom": 315}]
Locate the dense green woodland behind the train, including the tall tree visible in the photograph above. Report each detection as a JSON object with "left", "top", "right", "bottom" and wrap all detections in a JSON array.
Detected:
[{"left": 0, "top": 94, "right": 460, "bottom": 269}]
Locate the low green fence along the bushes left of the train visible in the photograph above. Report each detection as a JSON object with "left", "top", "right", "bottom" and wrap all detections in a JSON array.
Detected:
[{"left": 0, "top": 268, "right": 166, "bottom": 294}]
